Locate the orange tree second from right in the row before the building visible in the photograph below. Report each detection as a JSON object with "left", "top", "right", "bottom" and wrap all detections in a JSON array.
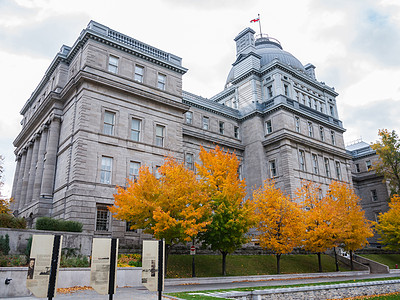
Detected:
[{"left": 296, "top": 181, "right": 339, "bottom": 272}]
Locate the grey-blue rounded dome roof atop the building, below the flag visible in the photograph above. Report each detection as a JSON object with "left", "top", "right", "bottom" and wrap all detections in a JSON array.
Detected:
[{"left": 226, "top": 35, "right": 305, "bottom": 83}]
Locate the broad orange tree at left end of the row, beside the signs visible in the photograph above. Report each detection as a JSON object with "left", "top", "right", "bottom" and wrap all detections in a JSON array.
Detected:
[{"left": 110, "top": 158, "right": 210, "bottom": 255}]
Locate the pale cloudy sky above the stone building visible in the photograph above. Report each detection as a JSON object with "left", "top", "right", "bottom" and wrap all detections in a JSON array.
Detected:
[{"left": 0, "top": 0, "right": 400, "bottom": 195}]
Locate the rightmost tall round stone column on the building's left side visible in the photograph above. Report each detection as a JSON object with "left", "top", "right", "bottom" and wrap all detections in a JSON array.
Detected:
[{"left": 40, "top": 117, "right": 60, "bottom": 199}]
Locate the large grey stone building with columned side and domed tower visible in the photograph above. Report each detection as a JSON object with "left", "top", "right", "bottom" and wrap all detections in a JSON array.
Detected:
[{"left": 12, "top": 21, "right": 352, "bottom": 238}]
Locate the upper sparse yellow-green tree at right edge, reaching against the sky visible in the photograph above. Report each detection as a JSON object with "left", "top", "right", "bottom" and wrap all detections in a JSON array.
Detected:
[{"left": 371, "top": 129, "right": 400, "bottom": 195}]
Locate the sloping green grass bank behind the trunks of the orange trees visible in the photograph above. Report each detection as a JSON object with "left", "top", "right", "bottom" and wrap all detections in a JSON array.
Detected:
[{"left": 167, "top": 254, "right": 349, "bottom": 278}]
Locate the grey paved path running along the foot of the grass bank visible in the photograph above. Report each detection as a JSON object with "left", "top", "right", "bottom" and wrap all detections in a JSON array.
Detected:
[{"left": 8, "top": 272, "right": 400, "bottom": 300}]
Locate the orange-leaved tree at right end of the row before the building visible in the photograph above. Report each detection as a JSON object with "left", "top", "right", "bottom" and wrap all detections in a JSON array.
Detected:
[{"left": 326, "top": 181, "right": 374, "bottom": 270}]
